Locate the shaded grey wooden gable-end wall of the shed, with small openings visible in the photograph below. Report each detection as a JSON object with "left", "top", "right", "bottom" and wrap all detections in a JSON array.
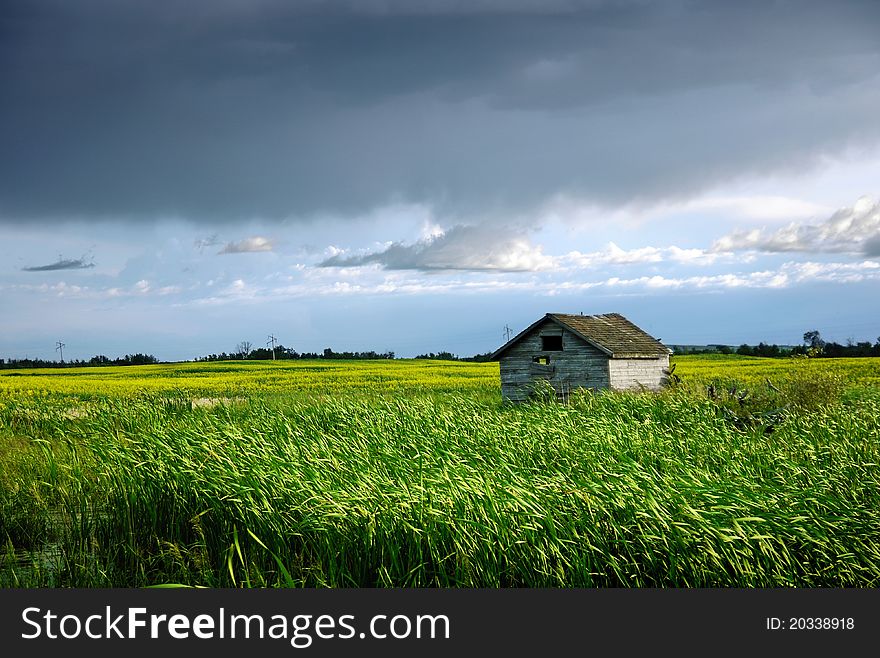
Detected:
[{"left": 500, "top": 320, "right": 610, "bottom": 402}]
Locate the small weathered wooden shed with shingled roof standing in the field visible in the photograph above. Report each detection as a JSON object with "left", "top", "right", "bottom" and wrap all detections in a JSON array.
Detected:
[{"left": 491, "top": 313, "right": 671, "bottom": 402}]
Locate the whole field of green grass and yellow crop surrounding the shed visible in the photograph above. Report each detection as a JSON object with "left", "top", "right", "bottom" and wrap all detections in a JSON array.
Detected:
[{"left": 0, "top": 357, "right": 880, "bottom": 587}]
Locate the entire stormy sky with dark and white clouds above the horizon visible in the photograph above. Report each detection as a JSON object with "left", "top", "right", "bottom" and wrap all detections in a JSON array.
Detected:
[{"left": 0, "top": 0, "right": 880, "bottom": 359}]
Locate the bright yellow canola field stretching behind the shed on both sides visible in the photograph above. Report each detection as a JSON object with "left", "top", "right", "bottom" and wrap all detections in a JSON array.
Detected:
[{"left": 0, "top": 355, "right": 880, "bottom": 399}]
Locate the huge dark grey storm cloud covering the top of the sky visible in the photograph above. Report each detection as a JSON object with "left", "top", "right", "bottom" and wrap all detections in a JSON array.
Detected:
[{"left": 0, "top": 0, "right": 880, "bottom": 221}]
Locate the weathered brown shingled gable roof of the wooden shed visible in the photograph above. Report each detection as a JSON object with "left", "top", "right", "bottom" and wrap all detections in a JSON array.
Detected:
[{"left": 490, "top": 313, "right": 670, "bottom": 360}]
